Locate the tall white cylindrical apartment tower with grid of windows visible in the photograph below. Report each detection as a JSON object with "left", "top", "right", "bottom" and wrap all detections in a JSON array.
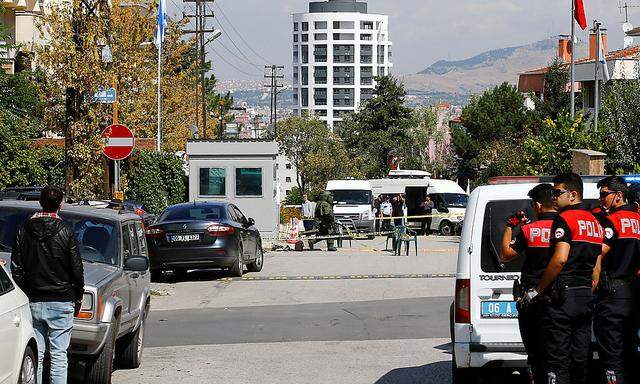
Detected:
[{"left": 293, "top": 0, "right": 392, "bottom": 128}]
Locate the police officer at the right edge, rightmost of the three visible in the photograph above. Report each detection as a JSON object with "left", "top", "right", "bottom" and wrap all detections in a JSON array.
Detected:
[{"left": 593, "top": 176, "right": 640, "bottom": 384}]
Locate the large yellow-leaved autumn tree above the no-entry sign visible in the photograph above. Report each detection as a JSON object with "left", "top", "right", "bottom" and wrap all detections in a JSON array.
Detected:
[{"left": 38, "top": 0, "right": 196, "bottom": 197}]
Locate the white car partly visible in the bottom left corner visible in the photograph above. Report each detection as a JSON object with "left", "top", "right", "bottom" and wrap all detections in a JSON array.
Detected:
[{"left": 0, "top": 262, "right": 38, "bottom": 384}]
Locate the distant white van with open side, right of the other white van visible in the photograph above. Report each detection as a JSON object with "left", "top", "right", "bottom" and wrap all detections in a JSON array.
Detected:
[{"left": 371, "top": 176, "right": 468, "bottom": 236}]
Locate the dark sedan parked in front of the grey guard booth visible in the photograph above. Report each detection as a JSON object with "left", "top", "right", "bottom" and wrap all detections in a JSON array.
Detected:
[{"left": 147, "top": 202, "right": 264, "bottom": 279}]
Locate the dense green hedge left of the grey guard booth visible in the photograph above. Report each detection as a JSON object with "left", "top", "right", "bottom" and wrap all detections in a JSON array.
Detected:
[{"left": 123, "top": 151, "right": 186, "bottom": 214}]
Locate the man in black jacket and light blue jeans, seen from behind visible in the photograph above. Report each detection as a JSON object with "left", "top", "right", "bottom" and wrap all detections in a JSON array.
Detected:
[{"left": 11, "top": 186, "right": 84, "bottom": 384}]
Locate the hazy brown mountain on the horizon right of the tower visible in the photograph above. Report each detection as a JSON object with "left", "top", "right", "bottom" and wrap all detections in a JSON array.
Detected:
[{"left": 401, "top": 38, "right": 586, "bottom": 101}]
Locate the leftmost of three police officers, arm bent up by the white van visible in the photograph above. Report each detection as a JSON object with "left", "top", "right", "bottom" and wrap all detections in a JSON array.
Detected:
[{"left": 500, "top": 184, "right": 557, "bottom": 383}]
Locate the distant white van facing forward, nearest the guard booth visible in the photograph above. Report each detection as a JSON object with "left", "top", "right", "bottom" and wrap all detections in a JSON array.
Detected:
[{"left": 326, "top": 180, "right": 374, "bottom": 233}]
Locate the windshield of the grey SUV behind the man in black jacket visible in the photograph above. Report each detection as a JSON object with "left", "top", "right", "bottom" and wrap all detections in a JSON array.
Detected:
[{"left": 0, "top": 208, "right": 119, "bottom": 265}]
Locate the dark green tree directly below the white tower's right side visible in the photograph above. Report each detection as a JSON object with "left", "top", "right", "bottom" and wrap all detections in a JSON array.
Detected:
[{"left": 340, "top": 76, "right": 416, "bottom": 178}]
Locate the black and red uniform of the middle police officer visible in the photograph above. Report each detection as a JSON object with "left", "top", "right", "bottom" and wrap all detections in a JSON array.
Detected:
[{"left": 541, "top": 204, "right": 604, "bottom": 384}]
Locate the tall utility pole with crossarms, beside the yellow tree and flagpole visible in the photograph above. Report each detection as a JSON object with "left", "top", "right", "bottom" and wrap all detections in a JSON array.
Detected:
[{"left": 183, "top": 0, "right": 222, "bottom": 140}]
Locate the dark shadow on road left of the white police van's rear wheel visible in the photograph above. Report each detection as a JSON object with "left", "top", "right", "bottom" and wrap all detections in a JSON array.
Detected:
[{"left": 375, "top": 361, "right": 452, "bottom": 384}]
